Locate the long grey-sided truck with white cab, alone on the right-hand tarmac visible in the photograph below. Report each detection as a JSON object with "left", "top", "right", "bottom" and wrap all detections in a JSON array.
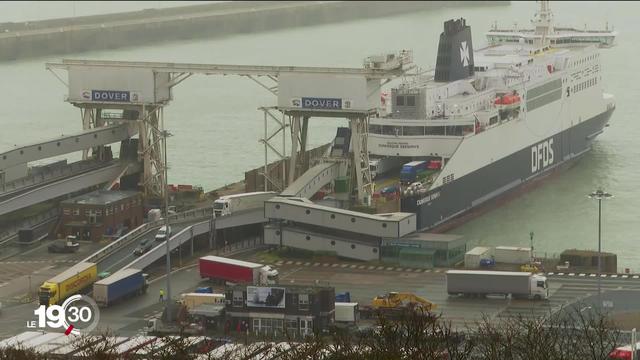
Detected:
[{"left": 445, "top": 270, "right": 549, "bottom": 300}]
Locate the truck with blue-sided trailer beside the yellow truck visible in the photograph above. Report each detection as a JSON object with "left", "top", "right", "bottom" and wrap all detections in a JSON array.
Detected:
[{"left": 93, "top": 269, "right": 149, "bottom": 307}]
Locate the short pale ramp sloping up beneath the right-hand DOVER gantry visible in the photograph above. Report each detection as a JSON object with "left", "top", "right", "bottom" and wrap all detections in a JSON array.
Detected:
[{"left": 280, "top": 162, "right": 340, "bottom": 199}]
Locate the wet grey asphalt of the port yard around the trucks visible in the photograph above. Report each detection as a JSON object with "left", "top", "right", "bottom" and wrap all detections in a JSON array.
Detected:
[{"left": 5, "top": 248, "right": 640, "bottom": 337}]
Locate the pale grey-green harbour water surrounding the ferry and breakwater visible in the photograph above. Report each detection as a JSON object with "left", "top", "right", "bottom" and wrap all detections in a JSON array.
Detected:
[{"left": 0, "top": 1, "right": 640, "bottom": 271}]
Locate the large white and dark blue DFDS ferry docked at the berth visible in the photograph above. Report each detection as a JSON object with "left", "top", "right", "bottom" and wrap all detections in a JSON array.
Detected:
[{"left": 368, "top": 5, "right": 615, "bottom": 229}]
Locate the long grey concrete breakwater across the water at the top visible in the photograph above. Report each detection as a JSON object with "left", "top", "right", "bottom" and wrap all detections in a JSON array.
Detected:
[{"left": 0, "top": 1, "right": 510, "bottom": 61}]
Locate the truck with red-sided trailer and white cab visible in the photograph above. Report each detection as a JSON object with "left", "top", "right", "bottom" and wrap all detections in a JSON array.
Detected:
[{"left": 198, "top": 255, "right": 278, "bottom": 285}]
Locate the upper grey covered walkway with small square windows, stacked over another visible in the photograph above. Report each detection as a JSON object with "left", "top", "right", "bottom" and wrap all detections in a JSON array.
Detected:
[{"left": 264, "top": 197, "right": 416, "bottom": 238}]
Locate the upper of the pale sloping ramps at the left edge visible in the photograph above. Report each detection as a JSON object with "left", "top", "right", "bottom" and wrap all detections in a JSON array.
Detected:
[{"left": 0, "top": 124, "right": 137, "bottom": 172}]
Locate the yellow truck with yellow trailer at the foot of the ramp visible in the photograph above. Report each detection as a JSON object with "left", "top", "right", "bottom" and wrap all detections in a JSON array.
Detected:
[{"left": 38, "top": 262, "right": 98, "bottom": 306}]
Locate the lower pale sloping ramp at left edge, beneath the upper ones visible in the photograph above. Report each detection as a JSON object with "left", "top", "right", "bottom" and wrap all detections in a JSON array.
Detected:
[{"left": 0, "top": 160, "right": 139, "bottom": 215}]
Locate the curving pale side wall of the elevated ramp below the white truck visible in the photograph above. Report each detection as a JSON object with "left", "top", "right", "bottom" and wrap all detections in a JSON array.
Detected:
[{"left": 122, "top": 208, "right": 267, "bottom": 269}]
